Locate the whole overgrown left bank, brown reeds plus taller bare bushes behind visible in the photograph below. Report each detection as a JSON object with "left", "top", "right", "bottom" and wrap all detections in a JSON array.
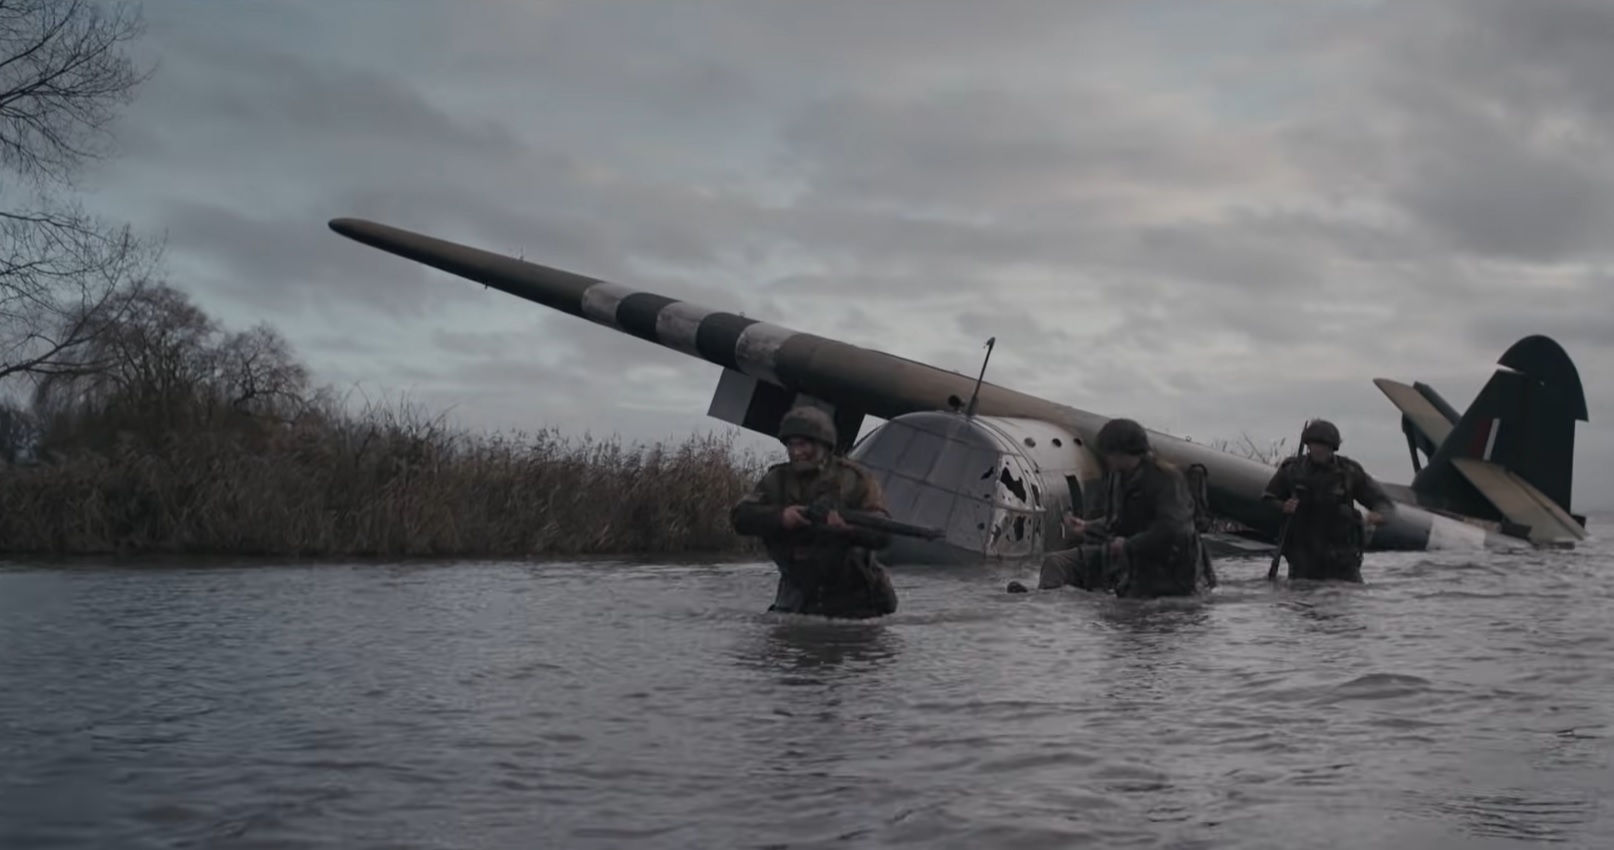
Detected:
[{"left": 0, "top": 285, "right": 767, "bottom": 558}]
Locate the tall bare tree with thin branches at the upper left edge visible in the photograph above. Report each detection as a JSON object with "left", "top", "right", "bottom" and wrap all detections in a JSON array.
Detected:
[{"left": 0, "top": 0, "right": 161, "bottom": 379}]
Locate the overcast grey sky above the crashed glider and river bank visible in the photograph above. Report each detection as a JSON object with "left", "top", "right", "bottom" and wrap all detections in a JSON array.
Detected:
[{"left": 69, "top": 0, "right": 1614, "bottom": 508}]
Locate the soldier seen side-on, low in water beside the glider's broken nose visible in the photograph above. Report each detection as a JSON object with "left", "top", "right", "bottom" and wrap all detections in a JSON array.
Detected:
[{"left": 1009, "top": 419, "right": 1211, "bottom": 598}]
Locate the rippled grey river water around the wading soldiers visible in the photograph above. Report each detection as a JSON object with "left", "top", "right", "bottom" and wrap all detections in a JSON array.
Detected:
[{"left": 0, "top": 524, "right": 1614, "bottom": 850}]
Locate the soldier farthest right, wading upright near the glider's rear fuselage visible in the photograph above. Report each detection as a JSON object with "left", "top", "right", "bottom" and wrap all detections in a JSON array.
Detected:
[{"left": 1262, "top": 419, "right": 1394, "bottom": 582}]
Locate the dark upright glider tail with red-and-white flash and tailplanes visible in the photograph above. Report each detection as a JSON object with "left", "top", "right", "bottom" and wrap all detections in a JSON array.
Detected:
[{"left": 1400, "top": 335, "right": 1588, "bottom": 542}]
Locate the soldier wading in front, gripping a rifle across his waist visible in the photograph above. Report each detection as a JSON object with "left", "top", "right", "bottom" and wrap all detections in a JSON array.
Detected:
[{"left": 730, "top": 406, "right": 897, "bottom": 619}]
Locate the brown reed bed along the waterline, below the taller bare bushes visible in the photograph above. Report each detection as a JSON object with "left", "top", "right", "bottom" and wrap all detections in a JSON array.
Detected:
[{"left": 0, "top": 410, "right": 765, "bottom": 556}]
